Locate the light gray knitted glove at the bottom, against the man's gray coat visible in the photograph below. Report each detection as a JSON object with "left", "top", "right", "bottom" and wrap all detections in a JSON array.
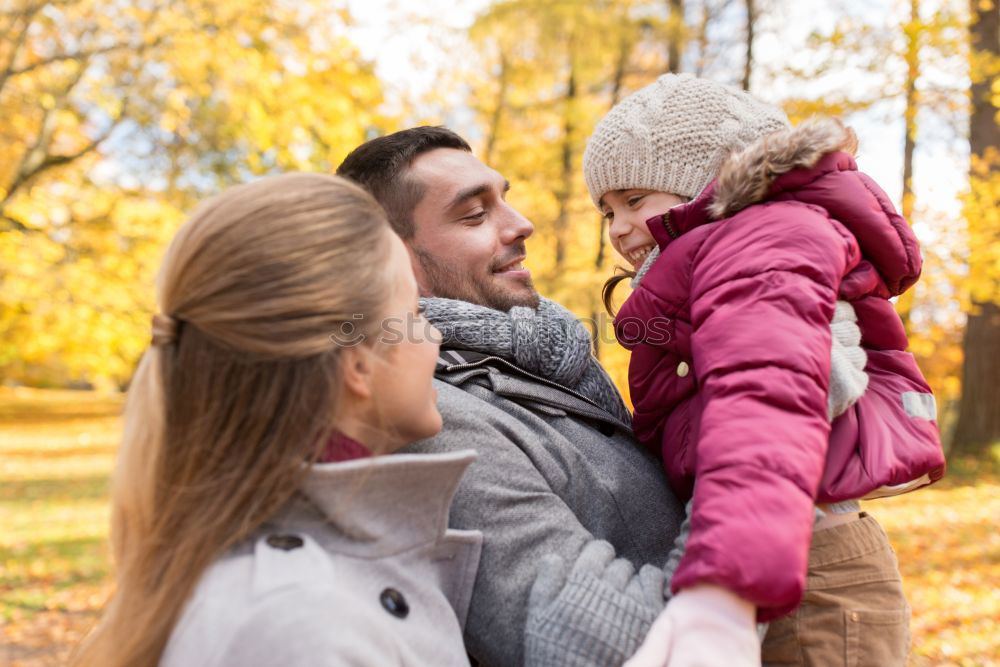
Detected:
[{"left": 524, "top": 541, "right": 665, "bottom": 667}]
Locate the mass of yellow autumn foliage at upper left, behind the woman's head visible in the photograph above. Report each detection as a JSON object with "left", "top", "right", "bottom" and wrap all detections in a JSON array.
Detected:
[{"left": 0, "top": 0, "right": 383, "bottom": 383}]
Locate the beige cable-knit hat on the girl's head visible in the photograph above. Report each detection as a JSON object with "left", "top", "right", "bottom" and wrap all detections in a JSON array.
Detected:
[{"left": 583, "top": 74, "right": 789, "bottom": 205}]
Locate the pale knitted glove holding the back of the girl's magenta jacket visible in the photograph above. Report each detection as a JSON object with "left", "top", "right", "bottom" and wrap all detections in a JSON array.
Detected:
[{"left": 826, "top": 301, "right": 868, "bottom": 421}]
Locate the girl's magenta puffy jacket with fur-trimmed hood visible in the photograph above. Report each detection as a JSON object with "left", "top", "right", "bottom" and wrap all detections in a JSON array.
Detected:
[{"left": 615, "top": 121, "right": 944, "bottom": 621}]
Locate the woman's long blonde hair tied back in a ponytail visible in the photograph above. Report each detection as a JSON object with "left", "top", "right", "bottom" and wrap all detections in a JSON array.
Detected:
[{"left": 74, "top": 174, "right": 392, "bottom": 667}]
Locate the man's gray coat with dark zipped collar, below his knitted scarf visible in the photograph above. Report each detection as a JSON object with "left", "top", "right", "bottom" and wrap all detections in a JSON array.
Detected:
[{"left": 407, "top": 351, "right": 684, "bottom": 665}]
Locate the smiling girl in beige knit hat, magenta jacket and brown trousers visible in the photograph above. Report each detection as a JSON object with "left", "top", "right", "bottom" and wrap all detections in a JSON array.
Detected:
[{"left": 584, "top": 75, "right": 944, "bottom": 665}]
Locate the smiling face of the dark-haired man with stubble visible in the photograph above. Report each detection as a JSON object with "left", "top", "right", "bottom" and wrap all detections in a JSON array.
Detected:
[{"left": 407, "top": 148, "right": 538, "bottom": 312}]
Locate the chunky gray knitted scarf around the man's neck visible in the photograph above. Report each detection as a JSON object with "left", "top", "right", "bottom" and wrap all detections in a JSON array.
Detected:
[{"left": 420, "top": 298, "right": 632, "bottom": 424}]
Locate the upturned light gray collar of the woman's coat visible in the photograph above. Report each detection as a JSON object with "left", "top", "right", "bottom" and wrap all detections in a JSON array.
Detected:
[{"left": 268, "top": 450, "right": 476, "bottom": 557}]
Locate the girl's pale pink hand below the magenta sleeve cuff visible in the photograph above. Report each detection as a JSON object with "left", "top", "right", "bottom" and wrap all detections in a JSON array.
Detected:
[{"left": 625, "top": 584, "right": 760, "bottom": 667}]
